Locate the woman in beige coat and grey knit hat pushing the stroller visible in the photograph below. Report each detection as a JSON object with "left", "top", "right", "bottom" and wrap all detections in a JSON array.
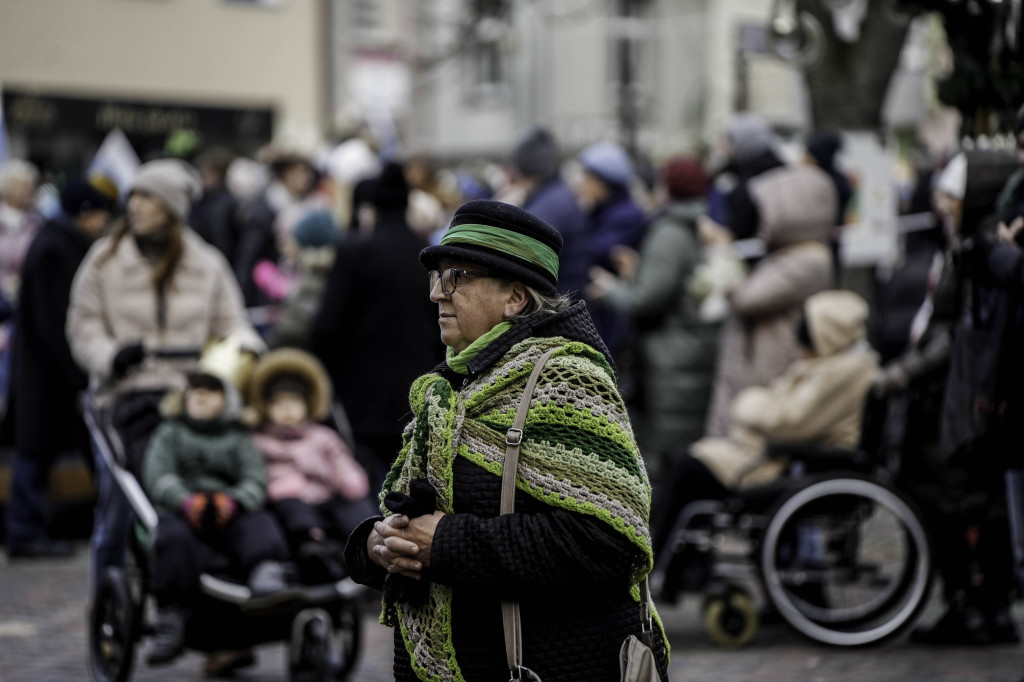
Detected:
[{"left": 67, "top": 160, "right": 263, "bottom": 585}]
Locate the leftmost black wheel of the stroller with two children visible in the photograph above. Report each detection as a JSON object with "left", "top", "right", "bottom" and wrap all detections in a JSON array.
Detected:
[{"left": 89, "top": 567, "right": 137, "bottom": 682}]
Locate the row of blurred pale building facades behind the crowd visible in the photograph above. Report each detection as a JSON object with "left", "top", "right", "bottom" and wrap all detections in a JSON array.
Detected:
[{"left": 0, "top": 0, "right": 942, "bottom": 166}]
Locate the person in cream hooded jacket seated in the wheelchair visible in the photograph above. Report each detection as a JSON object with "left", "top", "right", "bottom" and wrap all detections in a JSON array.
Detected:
[{"left": 652, "top": 291, "right": 879, "bottom": 596}]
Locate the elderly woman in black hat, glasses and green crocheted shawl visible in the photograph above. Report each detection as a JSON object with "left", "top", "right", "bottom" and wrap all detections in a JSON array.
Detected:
[{"left": 345, "top": 201, "right": 668, "bottom": 682}]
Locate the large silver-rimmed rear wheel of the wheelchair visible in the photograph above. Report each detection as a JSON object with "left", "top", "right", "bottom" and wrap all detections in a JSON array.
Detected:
[{"left": 760, "top": 475, "right": 932, "bottom": 646}]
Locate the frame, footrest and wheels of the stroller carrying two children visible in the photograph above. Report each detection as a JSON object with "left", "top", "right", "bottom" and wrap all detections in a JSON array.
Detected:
[{"left": 82, "top": 376, "right": 364, "bottom": 682}]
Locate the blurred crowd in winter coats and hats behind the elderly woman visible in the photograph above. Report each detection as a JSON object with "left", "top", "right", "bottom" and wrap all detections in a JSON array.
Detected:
[{"left": 0, "top": 100, "right": 1024, "bottom": 659}]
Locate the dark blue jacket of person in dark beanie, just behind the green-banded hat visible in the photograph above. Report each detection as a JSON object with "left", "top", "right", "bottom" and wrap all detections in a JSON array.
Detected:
[{"left": 523, "top": 175, "right": 590, "bottom": 293}]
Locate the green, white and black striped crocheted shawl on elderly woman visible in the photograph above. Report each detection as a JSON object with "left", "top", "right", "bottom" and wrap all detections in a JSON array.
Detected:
[{"left": 381, "top": 337, "right": 668, "bottom": 682}]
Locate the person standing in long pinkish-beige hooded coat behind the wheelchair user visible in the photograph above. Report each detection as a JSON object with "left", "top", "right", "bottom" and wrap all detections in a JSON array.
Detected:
[{"left": 704, "top": 166, "right": 837, "bottom": 436}]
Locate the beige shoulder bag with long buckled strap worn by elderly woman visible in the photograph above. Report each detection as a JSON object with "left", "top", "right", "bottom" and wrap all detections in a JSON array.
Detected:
[{"left": 501, "top": 349, "right": 662, "bottom": 682}]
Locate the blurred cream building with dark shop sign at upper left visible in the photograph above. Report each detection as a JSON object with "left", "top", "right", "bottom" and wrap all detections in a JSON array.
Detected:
[{"left": 0, "top": 0, "right": 329, "bottom": 168}]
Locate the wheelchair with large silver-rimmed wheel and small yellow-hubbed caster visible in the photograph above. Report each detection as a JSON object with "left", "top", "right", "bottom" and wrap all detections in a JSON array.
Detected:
[{"left": 651, "top": 403, "right": 933, "bottom": 647}]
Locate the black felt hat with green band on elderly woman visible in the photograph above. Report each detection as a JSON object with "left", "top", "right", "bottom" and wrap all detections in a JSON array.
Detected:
[{"left": 420, "top": 200, "right": 562, "bottom": 294}]
